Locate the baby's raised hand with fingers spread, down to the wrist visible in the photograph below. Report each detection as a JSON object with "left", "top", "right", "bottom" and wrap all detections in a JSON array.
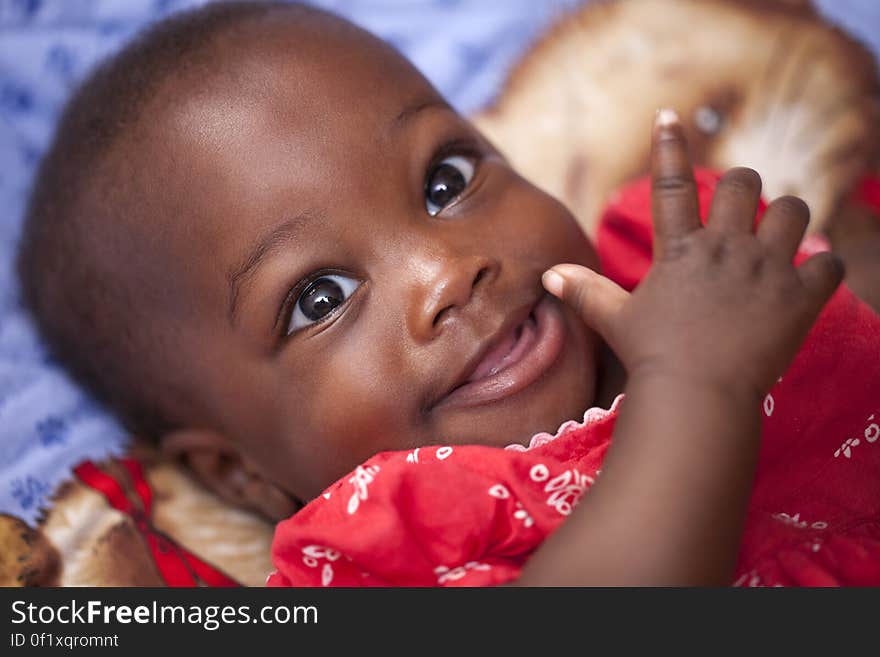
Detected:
[{"left": 544, "top": 110, "right": 843, "bottom": 399}]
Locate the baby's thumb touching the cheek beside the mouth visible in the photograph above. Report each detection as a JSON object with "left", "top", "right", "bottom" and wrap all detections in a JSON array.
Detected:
[{"left": 541, "top": 265, "right": 629, "bottom": 347}]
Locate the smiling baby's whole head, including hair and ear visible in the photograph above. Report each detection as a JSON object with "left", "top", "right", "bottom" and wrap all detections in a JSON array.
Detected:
[{"left": 19, "top": 4, "right": 597, "bottom": 516}]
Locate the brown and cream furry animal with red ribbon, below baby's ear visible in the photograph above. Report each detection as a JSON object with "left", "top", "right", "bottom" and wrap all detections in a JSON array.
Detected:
[{"left": 0, "top": 444, "right": 273, "bottom": 586}]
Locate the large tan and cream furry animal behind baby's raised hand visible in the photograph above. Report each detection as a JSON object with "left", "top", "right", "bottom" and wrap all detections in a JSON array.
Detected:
[{"left": 476, "top": 0, "right": 880, "bottom": 235}]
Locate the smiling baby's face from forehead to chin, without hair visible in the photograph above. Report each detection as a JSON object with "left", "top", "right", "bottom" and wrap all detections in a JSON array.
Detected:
[{"left": 143, "top": 15, "right": 597, "bottom": 499}]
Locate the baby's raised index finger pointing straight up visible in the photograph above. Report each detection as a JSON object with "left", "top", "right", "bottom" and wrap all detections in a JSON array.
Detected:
[{"left": 651, "top": 109, "right": 701, "bottom": 254}]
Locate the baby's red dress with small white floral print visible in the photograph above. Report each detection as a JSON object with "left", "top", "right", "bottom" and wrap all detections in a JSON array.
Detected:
[{"left": 267, "top": 172, "right": 880, "bottom": 586}]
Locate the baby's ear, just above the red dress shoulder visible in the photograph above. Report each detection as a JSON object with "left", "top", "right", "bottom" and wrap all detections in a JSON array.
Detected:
[{"left": 159, "top": 429, "right": 301, "bottom": 522}]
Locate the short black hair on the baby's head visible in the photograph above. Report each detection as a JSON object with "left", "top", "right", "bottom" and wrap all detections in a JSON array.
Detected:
[{"left": 17, "top": 2, "right": 310, "bottom": 438}]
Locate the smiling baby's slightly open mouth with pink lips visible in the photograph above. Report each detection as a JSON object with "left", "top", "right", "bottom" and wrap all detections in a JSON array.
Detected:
[{"left": 435, "top": 294, "right": 565, "bottom": 408}]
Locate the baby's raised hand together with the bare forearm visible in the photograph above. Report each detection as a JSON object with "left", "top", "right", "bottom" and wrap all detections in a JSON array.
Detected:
[{"left": 520, "top": 111, "right": 843, "bottom": 586}]
